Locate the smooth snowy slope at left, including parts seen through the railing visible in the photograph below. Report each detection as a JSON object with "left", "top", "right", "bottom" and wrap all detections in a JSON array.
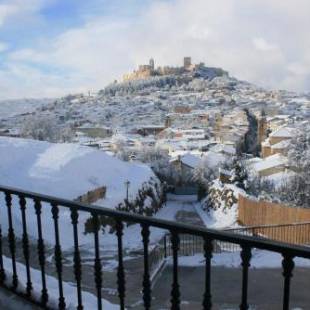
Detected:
[{"left": 0, "top": 137, "right": 160, "bottom": 250}]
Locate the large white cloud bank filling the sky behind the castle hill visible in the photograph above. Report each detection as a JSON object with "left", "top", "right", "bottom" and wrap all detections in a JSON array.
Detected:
[{"left": 1, "top": 0, "right": 310, "bottom": 95}]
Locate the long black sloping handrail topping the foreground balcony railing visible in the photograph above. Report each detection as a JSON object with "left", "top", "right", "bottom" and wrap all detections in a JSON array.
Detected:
[{"left": 0, "top": 186, "right": 310, "bottom": 258}]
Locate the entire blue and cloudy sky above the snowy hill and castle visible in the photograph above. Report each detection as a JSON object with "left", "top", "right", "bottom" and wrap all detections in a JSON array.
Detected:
[{"left": 0, "top": 0, "right": 310, "bottom": 99}]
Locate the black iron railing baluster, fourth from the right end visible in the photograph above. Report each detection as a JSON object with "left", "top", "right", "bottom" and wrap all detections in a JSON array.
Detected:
[{"left": 171, "top": 231, "right": 180, "bottom": 310}]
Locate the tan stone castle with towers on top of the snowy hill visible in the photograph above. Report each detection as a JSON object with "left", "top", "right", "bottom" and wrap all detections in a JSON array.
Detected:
[{"left": 123, "top": 57, "right": 204, "bottom": 81}]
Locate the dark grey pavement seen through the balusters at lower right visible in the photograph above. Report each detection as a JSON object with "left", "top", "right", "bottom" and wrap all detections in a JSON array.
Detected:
[{"left": 152, "top": 266, "right": 310, "bottom": 310}]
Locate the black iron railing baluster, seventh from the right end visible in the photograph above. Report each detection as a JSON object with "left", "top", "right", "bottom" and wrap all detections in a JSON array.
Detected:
[{"left": 92, "top": 213, "right": 102, "bottom": 310}]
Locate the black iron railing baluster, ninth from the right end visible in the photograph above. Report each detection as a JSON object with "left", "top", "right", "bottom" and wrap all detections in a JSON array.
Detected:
[{"left": 52, "top": 203, "right": 66, "bottom": 310}]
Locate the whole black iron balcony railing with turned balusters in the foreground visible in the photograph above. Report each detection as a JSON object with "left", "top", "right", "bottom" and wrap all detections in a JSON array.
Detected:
[{"left": 0, "top": 187, "right": 310, "bottom": 310}]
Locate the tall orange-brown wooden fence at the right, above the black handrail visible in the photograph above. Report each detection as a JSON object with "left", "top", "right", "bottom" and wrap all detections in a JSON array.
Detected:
[{"left": 238, "top": 195, "right": 310, "bottom": 244}]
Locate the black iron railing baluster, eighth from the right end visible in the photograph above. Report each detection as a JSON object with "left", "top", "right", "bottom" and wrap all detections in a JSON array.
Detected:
[{"left": 71, "top": 208, "right": 83, "bottom": 310}]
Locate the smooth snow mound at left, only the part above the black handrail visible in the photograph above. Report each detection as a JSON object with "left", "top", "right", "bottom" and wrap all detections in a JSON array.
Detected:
[{"left": 0, "top": 137, "right": 155, "bottom": 208}]
